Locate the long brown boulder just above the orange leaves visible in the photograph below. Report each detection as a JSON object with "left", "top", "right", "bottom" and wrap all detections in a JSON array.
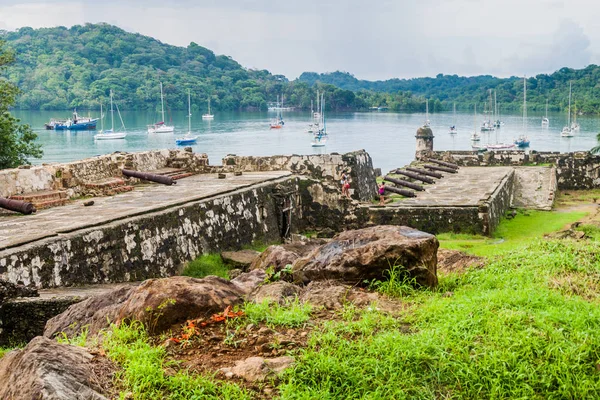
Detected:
[{"left": 44, "top": 276, "right": 244, "bottom": 337}]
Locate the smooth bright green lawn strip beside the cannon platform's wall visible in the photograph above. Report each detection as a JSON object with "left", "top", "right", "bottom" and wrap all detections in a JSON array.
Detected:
[{"left": 437, "top": 211, "right": 587, "bottom": 257}]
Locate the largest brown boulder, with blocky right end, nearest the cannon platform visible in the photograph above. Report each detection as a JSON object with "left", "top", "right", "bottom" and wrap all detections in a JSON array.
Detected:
[{"left": 293, "top": 225, "right": 439, "bottom": 287}]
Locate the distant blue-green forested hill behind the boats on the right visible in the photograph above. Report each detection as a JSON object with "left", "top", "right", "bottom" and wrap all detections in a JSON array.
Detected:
[{"left": 298, "top": 65, "right": 600, "bottom": 114}]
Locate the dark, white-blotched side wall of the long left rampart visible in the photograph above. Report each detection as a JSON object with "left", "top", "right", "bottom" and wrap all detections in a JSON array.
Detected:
[{"left": 0, "top": 177, "right": 301, "bottom": 288}]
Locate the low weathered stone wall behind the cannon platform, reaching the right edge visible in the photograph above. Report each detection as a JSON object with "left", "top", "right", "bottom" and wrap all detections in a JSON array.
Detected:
[{"left": 429, "top": 150, "right": 600, "bottom": 190}]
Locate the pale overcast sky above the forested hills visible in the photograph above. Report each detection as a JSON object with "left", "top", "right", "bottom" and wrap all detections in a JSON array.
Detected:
[{"left": 0, "top": 0, "right": 600, "bottom": 80}]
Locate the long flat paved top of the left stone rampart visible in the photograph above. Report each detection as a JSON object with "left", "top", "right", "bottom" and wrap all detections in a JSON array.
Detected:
[{"left": 0, "top": 171, "right": 291, "bottom": 251}]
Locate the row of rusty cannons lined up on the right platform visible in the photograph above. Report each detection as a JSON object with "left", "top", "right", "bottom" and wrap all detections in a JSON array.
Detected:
[{"left": 383, "top": 159, "right": 458, "bottom": 197}]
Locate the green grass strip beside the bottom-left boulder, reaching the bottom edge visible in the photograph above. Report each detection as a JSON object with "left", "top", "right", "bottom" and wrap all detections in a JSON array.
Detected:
[{"left": 102, "top": 322, "right": 251, "bottom": 400}]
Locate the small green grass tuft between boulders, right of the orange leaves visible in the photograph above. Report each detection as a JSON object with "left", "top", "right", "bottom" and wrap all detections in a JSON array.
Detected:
[{"left": 244, "top": 298, "right": 313, "bottom": 328}]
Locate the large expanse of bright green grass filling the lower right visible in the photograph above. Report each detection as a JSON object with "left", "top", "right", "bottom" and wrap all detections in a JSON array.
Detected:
[{"left": 280, "top": 240, "right": 600, "bottom": 399}]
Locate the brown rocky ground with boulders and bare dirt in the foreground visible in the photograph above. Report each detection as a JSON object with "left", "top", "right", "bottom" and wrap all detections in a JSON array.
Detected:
[{"left": 0, "top": 226, "right": 482, "bottom": 399}]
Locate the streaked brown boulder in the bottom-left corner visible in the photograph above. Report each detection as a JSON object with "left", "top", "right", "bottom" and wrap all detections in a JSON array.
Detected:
[{"left": 0, "top": 336, "right": 106, "bottom": 400}]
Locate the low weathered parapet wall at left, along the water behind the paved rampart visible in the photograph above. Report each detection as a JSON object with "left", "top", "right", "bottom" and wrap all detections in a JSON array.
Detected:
[{"left": 0, "top": 150, "right": 208, "bottom": 197}]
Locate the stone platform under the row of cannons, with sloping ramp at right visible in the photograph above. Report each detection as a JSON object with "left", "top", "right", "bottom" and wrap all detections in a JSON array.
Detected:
[{"left": 362, "top": 166, "right": 557, "bottom": 235}]
